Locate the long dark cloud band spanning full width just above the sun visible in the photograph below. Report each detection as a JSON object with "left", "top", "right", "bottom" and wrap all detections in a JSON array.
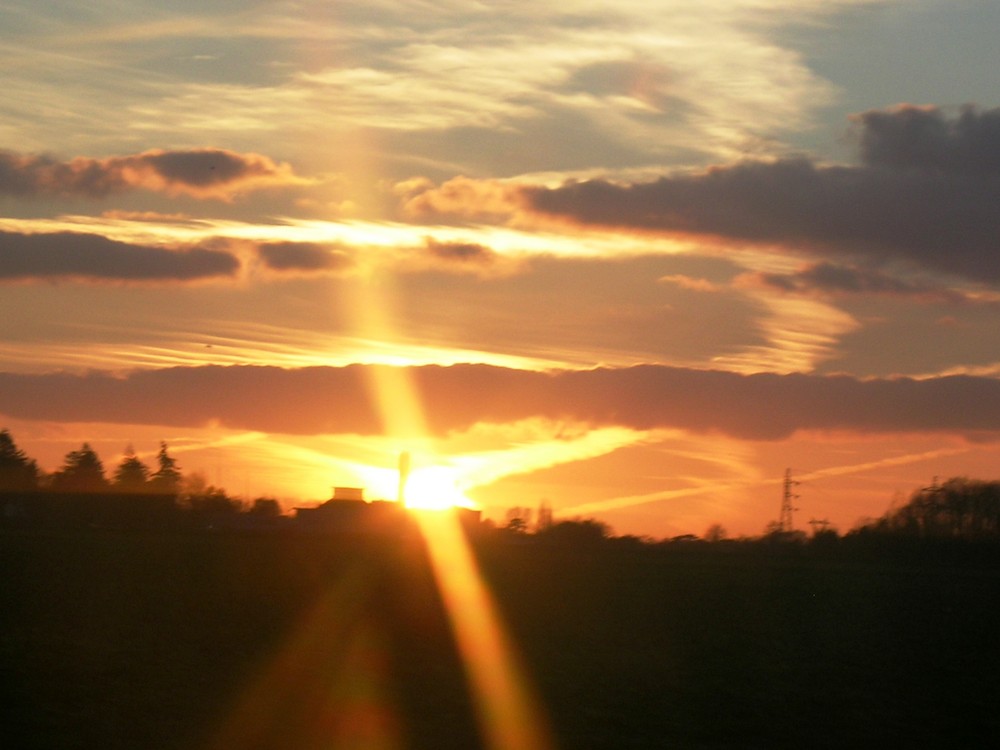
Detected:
[{"left": 0, "top": 365, "right": 1000, "bottom": 440}]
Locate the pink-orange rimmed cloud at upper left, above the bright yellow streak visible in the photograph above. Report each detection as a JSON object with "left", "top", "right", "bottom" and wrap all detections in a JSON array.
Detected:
[{"left": 0, "top": 148, "right": 304, "bottom": 200}]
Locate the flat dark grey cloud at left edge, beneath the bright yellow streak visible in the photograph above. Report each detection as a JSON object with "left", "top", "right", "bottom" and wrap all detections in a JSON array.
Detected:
[{"left": 0, "top": 231, "right": 240, "bottom": 281}]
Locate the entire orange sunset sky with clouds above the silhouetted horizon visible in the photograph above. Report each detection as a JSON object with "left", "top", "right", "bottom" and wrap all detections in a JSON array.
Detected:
[{"left": 0, "top": 0, "right": 1000, "bottom": 538}]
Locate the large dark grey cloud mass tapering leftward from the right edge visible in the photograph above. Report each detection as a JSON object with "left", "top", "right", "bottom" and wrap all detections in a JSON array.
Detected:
[{"left": 520, "top": 106, "right": 1000, "bottom": 283}]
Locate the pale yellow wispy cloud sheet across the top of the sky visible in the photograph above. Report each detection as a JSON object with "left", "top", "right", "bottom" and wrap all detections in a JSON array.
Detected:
[{"left": 1, "top": 0, "right": 892, "bottom": 176}]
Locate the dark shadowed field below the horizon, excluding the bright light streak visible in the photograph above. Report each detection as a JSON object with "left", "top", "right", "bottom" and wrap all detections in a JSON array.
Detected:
[{"left": 0, "top": 532, "right": 1000, "bottom": 750}]
